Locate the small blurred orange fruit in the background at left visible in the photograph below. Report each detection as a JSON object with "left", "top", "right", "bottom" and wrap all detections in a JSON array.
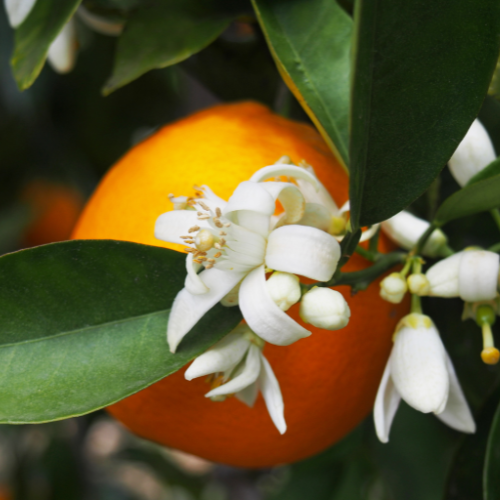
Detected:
[{"left": 21, "top": 180, "right": 84, "bottom": 247}]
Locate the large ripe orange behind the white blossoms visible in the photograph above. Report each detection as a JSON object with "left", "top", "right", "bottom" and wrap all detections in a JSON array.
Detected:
[{"left": 73, "top": 103, "right": 407, "bottom": 467}]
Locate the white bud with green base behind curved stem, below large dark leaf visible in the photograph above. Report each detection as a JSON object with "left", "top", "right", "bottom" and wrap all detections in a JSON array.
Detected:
[{"left": 382, "top": 211, "right": 448, "bottom": 257}]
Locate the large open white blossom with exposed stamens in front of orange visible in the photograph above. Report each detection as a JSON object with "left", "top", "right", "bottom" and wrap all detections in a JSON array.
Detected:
[{"left": 155, "top": 164, "right": 340, "bottom": 352}]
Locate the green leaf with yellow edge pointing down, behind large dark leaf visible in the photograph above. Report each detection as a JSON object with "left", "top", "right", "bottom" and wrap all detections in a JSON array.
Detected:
[{"left": 252, "top": 0, "right": 352, "bottom": 166}]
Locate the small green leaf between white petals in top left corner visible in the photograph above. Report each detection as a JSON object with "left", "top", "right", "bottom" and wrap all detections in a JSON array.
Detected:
[{"left": 11, "top": 0, "right": 81, "bottom": 90}]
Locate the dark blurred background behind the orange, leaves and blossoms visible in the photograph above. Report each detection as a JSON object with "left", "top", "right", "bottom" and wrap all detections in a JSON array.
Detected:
[{"left": 0, "top": 3, "right": 500, "bottom": 500}]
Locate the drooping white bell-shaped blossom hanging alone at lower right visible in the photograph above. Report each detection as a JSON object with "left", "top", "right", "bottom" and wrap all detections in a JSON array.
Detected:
[{"left": 374, "top": 313, "right": 476, "bottom": 443}]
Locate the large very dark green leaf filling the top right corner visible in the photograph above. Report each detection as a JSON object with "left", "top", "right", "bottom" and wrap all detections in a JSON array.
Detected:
[{"left": 350, "top": 0, "right": 500, "bottom": 229}]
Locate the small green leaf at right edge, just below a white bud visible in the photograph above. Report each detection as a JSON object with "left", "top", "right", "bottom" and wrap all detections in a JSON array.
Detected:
[{"left": 434, "top": 174, "right": 500, "bottom": 226}]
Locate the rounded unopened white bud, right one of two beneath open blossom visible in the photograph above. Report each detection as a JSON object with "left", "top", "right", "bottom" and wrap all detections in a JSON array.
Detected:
[{"left": 299, "top": 287, "right": 351, "bottom": 330}]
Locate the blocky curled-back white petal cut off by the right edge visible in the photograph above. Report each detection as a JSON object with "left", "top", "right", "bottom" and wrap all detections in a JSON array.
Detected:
[{"left": 458, "top": 250, "right": 500, "bottom": 302}]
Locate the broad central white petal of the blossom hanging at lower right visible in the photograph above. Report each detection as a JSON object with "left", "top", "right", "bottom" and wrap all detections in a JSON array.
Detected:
[{"left": 389, "top": 325, "right": 449, "bottom": 413}]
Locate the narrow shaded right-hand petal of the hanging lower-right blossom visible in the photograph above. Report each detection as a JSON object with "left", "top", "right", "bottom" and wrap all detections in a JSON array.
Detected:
[{"left": 437, "top": 354, "right": 476, "bottom": 433}]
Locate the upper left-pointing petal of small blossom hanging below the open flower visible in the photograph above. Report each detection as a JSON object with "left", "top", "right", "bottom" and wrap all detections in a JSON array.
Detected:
[{"left": 184, "top": 333, "right": 250, "bottom": 380}]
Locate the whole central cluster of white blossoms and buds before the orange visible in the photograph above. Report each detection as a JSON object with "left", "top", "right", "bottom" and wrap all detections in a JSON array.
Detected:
[{"left": 155, "top": 158, "right": 356, "bottom": 432}]
